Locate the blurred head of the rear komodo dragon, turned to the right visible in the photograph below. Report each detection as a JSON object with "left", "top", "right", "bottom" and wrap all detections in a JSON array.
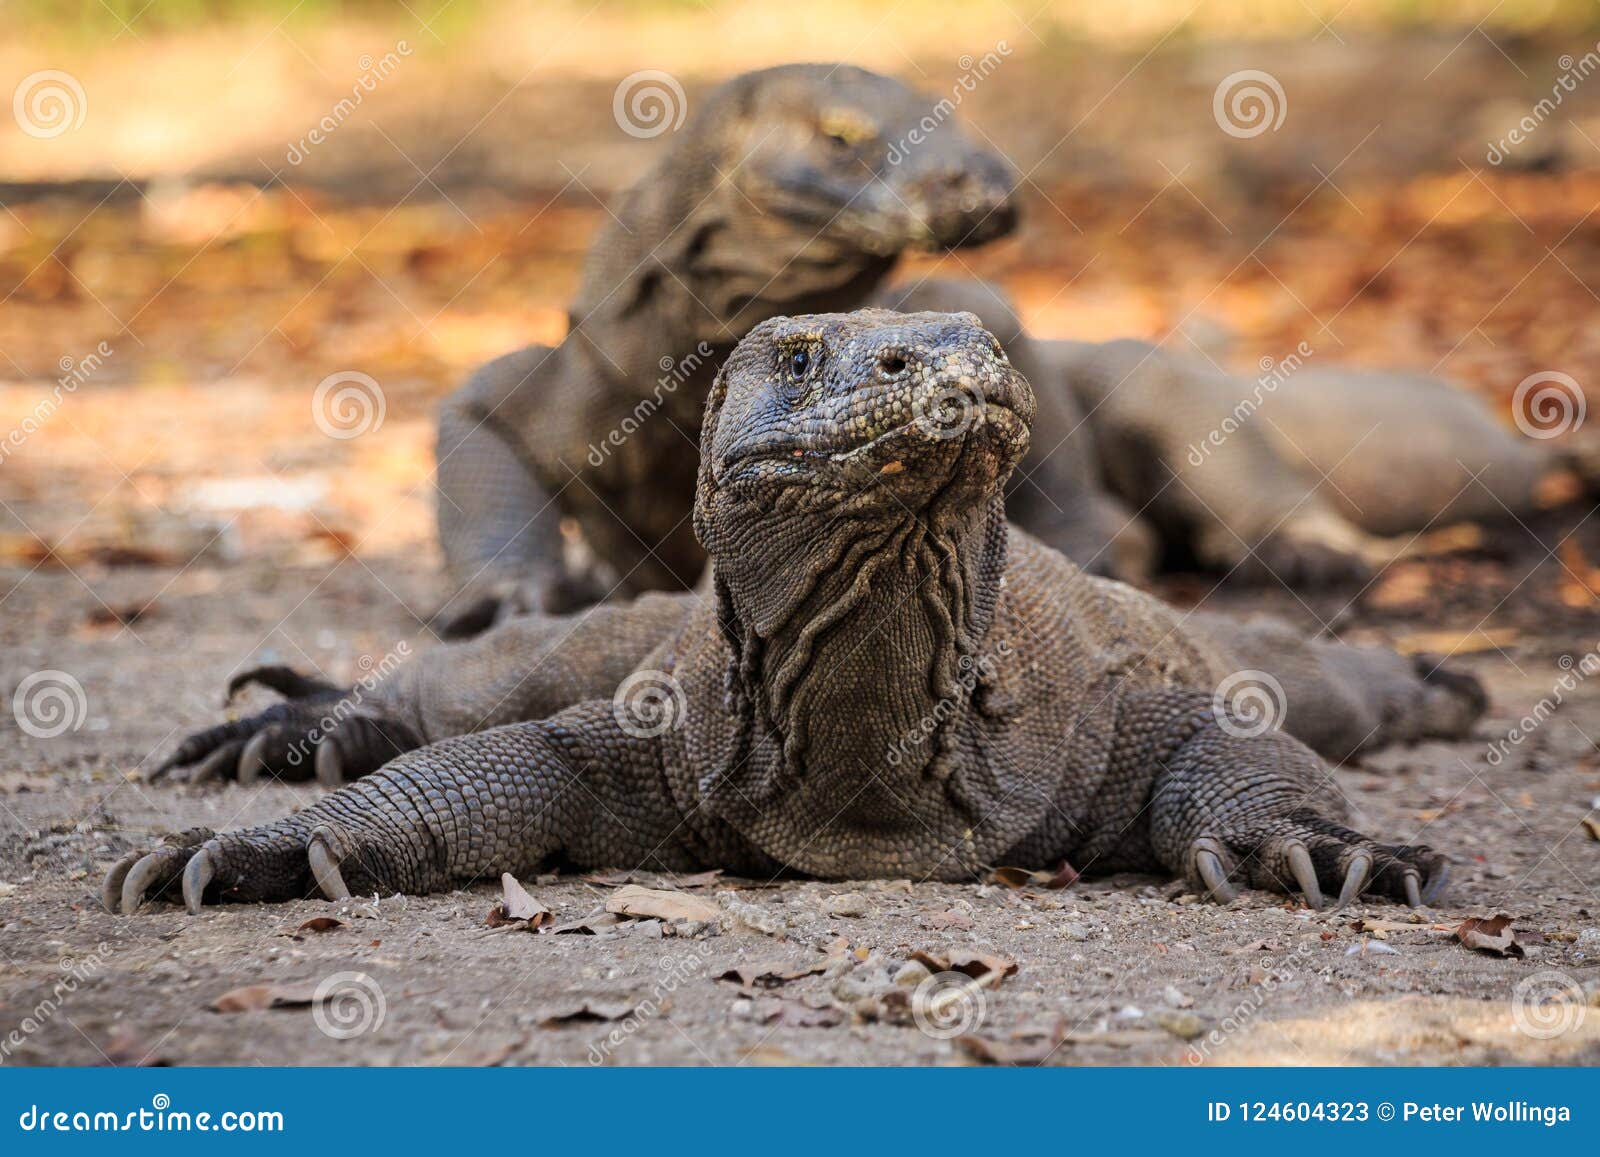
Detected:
[{"left": 573, "top": 64, "right": 1018, "bottom": 344}]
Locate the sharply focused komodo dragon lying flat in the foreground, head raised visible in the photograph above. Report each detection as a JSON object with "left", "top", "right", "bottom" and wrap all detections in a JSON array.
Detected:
[{"left": 104, "top": 310, "right": 1483, "bottom": 912}]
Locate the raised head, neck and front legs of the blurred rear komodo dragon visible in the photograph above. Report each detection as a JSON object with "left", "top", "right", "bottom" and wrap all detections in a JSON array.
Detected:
[{"left": 435, "top": 64, "right": 1126, "bottom": 637}]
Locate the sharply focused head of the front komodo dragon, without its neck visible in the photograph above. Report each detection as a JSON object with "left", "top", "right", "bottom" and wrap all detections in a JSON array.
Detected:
[{"left": 701, "top": 309, "right": 1034, "bottom": 512}]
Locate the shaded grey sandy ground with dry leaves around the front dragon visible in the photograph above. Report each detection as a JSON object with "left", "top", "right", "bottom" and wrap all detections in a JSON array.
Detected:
[{"left": 0, "top": 537, "right": 1600, "bottom": 1064}]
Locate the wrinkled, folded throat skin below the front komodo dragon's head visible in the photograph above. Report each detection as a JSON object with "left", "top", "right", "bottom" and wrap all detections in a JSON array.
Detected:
[{"left": 714, "top": 491, "right": 1006, "bottom": 832}]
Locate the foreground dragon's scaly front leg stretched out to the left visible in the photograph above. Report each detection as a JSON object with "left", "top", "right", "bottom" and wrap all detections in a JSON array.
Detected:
[{"left": 102, "top": 699, "right": 694, "bottom": 912}]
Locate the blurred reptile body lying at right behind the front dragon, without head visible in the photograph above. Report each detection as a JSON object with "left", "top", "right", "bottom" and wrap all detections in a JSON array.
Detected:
[{"left": 874, "top": 278, "right": 1568, "bottom": 586}]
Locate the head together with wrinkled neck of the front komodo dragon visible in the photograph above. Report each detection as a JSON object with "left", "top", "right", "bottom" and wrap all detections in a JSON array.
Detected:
[{"left": 694, "top": 309, "right": 1034, "bottom": 871}]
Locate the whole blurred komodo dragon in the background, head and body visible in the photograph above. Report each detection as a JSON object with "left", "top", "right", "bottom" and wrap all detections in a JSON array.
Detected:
[{"left": 435, "top": 64, "right": 1574, "bottom": 637}]
